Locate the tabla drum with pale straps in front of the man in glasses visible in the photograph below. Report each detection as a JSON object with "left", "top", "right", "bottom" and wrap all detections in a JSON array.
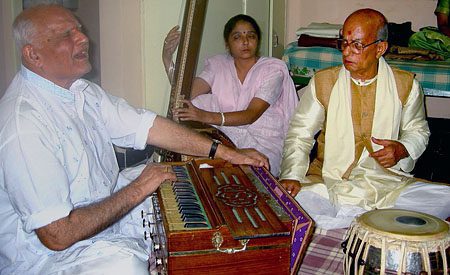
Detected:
[{"left": 342, "top": 209, "right": 450, "bottom": 275}]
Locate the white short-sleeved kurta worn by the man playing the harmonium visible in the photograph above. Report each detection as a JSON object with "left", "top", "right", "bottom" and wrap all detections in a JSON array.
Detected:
[{"left": 0, "top": 67, "right": 156, "bottom": 274}]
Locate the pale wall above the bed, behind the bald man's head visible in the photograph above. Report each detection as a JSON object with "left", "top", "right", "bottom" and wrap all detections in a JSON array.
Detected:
[{"left": 285, "top": 0, "right": 437, "bottom": 43}]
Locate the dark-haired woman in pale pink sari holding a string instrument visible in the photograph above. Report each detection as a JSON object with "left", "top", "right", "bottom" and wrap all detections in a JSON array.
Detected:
[{"left": 163, "top": 14, "right": 298, "bottom": 176}]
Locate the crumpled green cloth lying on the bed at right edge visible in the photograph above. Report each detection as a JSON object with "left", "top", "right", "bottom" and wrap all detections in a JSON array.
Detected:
[{"left": 409, "top": 27, "right": 450, "bottom": 60}]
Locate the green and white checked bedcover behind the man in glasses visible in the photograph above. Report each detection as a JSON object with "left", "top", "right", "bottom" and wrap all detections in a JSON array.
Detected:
[{"left": 283, "top": 41, "right": 450, "bottom": 97}]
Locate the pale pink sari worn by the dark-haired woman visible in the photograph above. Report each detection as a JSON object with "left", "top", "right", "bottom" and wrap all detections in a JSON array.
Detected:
[{"left": 192, "top": 54, "right": 298, "bottom": 176}]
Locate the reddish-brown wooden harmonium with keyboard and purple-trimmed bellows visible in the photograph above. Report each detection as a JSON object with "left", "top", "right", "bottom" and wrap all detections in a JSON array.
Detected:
[{"left": 144, "top": 159, "right": 313, "bottom": 274}]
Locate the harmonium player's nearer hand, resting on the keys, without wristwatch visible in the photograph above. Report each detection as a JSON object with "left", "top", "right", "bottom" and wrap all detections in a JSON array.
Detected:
[{"left": 133, "top": 163, "right": 177, "bottom": 195}]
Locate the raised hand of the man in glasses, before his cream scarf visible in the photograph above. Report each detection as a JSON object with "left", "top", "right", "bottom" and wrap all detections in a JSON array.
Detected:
[{"left": 370, "top": 137, "right": 409, "bottom": 168}]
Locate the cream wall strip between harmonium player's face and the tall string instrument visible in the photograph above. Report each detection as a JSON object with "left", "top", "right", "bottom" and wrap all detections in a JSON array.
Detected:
[{"left": 99, "top": 0, "right": 144, "bottom": 107}]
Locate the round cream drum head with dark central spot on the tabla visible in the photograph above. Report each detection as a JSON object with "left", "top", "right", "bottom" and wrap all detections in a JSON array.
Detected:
[{"left": 357, "top": 209, "right": 449, "bottom": 241}]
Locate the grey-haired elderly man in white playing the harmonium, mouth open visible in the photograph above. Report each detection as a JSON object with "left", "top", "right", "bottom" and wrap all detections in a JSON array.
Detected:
[{"left": 0, "top": 5, "right": 268, "bottom": 274}]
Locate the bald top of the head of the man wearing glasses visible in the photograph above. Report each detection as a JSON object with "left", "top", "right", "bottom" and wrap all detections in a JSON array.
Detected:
[{"left": 344, "top": 9, "right": 388, "bottom": 41}]
